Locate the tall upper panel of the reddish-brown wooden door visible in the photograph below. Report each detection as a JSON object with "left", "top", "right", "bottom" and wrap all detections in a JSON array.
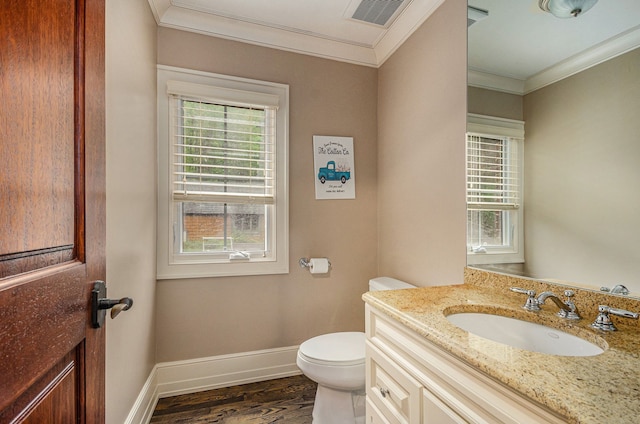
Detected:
[{"left": 0, "top": 0, "right": 76, "bottom": 262}]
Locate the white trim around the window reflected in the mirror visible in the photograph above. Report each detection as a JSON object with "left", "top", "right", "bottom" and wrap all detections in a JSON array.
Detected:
[{"left": 467, "top": 113, "right": 524, "bottom": 265}]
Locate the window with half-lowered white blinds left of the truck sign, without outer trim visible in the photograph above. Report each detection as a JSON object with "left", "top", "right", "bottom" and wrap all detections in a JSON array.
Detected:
[{"left": 171, "top": 95, "right": 275, "bottom": 255}]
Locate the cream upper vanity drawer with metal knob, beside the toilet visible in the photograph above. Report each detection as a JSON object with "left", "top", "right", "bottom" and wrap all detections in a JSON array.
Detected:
[{"left": 366, "top": 341, "right": 422, "bottom": 424}]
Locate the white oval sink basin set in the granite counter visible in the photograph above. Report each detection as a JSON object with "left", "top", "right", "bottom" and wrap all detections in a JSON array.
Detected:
[{"left": 447, "top": 312, "right": 604, "bottom": 356}]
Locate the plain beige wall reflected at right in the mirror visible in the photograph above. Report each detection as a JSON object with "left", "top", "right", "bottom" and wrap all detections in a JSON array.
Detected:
[{"left": 524, "top": 49, "right": 640, "bottom": 292}]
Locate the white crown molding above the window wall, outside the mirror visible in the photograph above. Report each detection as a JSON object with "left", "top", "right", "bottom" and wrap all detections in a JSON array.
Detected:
[{"left": 148, "top": 0, "right": 444, "bottom": 68}]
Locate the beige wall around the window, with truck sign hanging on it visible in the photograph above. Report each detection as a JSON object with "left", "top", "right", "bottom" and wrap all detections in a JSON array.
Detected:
[{"left": 156, "top": 28, "right": 380, "bottom": 362}]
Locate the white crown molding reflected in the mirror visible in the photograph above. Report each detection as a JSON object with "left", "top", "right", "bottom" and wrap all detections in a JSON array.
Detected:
[{"left": 468, "top": 25, "right": 640, "bottom": 95}]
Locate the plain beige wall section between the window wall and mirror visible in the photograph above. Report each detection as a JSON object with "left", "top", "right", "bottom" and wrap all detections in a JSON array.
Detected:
[{"left": 378, "top": 0, "right": 467, "bottom": 286}]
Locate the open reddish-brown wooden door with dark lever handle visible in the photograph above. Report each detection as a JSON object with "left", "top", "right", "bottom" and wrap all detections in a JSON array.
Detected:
[{"left": 0, "top": 0, "right": 105, "bottom": 423}]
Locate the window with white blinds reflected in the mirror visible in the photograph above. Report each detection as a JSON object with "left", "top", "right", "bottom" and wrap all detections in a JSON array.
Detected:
[{"left": 466, "top": 116, "right": 524, "bottom": 264}]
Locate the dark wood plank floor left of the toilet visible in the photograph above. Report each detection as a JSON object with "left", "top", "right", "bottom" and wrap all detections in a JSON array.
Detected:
[{"left": 151, "top": 375, "right": 316, "bottom": 424}]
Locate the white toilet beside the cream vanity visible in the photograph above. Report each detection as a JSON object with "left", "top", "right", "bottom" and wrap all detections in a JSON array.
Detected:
[{"left": 296, "top": 277, "right": 415, "bottom": 424}]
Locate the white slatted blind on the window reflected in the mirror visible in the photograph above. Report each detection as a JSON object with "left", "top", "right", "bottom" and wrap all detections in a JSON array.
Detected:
[{"left": 467, "top": 133, "right": 520, "bottom": 210}]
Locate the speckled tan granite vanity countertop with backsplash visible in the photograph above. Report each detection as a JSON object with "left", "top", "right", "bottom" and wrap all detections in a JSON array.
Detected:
[{"left": 363, "top": 269, "right": 640, "bottom": 424}]
